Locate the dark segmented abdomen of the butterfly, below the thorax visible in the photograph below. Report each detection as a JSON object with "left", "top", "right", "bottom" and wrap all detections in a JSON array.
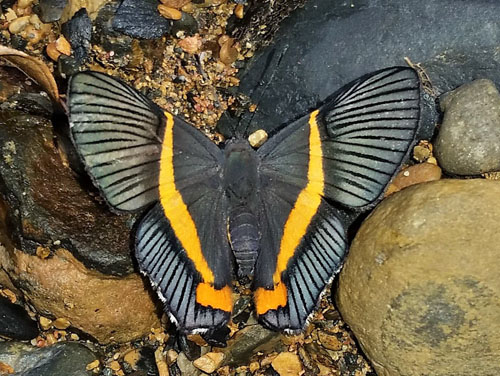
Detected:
[{"left": 229, "top": 206, "right": 260, "bottom": 277}]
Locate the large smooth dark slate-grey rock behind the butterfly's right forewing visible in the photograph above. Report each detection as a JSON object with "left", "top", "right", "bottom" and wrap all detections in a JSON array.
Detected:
[{"left": 233, "top": 0, "right": 500, "bottom": 138}]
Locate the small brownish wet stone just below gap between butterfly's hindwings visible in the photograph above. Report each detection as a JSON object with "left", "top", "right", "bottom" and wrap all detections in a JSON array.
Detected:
[{"left": 223, "top": 324, "right": 280, "bottom": 366}]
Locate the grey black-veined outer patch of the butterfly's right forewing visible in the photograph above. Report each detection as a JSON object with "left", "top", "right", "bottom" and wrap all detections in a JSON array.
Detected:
[{"left": 318, "top": 67, "right": 420, "bottom": 208}]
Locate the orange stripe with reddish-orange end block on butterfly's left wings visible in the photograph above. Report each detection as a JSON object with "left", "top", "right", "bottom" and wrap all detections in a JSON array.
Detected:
[{"left": 159, "top": 112, "right": 232, "bottom": 312}]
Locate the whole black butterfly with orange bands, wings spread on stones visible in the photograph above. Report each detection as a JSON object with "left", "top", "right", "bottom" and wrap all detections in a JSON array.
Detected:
[{"left": 68, "top": 67, "right": 420, "bottom": 333}]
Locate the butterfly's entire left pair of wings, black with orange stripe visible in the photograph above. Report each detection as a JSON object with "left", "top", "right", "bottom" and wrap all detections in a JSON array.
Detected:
[{"left": 69, "top": 72, "right": 232, "bottom": 332}]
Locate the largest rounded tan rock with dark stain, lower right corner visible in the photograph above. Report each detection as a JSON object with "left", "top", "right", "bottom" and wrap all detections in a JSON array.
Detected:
[{"left": 337, "top": 180, "right": 500, "bottom": 376}]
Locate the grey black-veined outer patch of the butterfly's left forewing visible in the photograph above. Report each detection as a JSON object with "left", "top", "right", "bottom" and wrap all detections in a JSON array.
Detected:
[{"left": 68, "top": 72, "right": 164, "bottom": 211}]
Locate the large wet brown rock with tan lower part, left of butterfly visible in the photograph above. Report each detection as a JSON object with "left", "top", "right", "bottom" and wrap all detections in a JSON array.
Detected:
[{"left": 0, "top": 67, "right": 160, "bottom": 343}]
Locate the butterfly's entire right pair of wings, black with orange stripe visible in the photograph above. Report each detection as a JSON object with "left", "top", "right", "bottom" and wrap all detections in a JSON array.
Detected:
[{"left": 255, "top": 67, "right": 419, "bottom": 331}]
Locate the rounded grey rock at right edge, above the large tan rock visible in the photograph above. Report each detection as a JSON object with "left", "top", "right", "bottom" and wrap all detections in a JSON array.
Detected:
[{"left": 434, "top": 80, "right": 500, "bottom": 175}]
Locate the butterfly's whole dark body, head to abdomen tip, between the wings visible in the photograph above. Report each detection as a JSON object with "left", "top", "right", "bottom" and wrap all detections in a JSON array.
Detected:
[{"left": 223, "top": 140, "right": 260, "bottom": 277}]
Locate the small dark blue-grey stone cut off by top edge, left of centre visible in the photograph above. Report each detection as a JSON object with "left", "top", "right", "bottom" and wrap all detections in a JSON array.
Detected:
[{"left": 113, "top": 0, "right": 171, "bottom": 39}]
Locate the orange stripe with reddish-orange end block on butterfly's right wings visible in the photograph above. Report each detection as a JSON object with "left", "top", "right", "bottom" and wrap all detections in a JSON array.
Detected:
[{"left": 255, "top": 110, "right": 325, "bottom": 314}]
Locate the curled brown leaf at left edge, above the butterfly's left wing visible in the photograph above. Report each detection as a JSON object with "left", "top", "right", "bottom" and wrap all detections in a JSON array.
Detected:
[{"left": 0, "top": 45, "right": 59, "bottom": 102}]
